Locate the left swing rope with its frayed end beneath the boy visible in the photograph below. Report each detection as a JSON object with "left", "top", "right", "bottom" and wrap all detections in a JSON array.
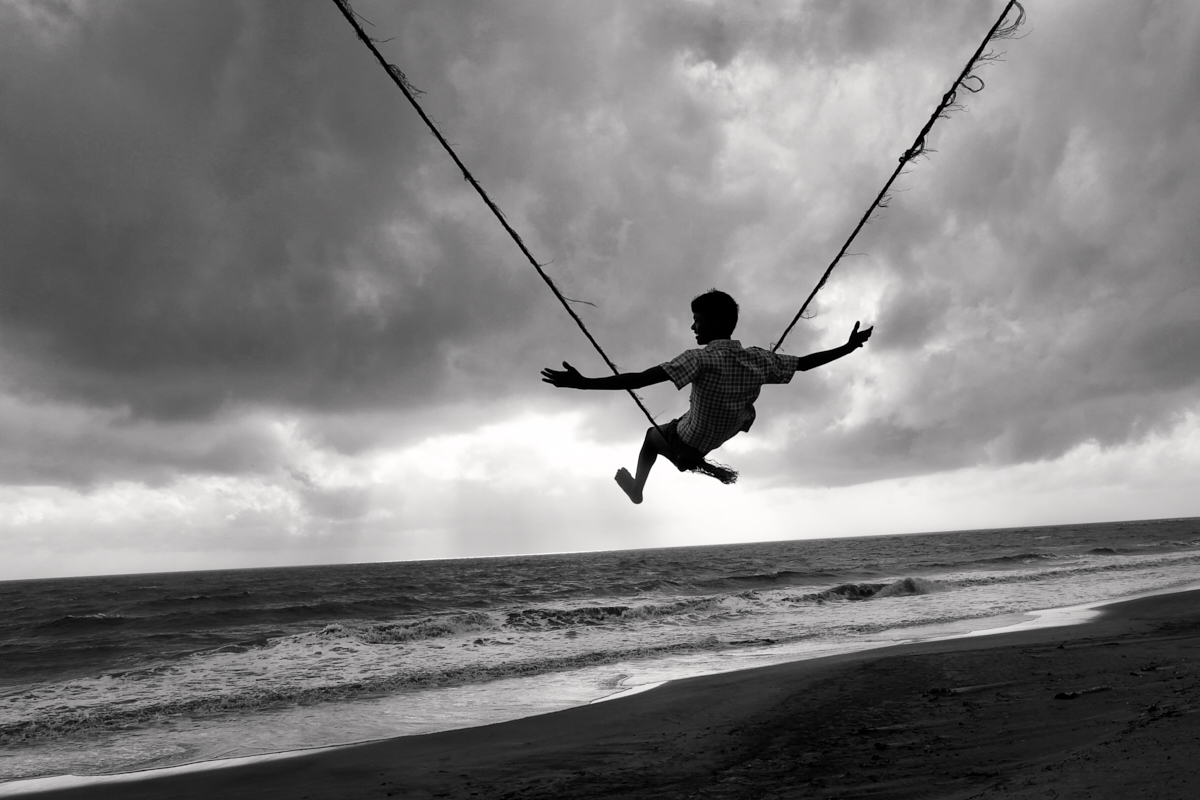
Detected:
[{"left": 334, "top": 0, "right": 738, "bottom": 483}]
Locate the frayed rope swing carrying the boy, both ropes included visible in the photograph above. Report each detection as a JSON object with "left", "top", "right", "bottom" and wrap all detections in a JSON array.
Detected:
[{"left": 334, "top": 0, "right": 1025, "bottom": 483}]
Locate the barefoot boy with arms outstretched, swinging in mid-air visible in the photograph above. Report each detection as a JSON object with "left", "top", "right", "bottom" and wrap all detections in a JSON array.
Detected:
[{"left": 541, "top": 289, "right": 872, "bottom": 503}]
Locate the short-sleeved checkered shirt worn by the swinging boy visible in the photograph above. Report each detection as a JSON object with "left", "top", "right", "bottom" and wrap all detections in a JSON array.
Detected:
[{"left": 662, "top": 339, "right": 800, "bottom": 453}]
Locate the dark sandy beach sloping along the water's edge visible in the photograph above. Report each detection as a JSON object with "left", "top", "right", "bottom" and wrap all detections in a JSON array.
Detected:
[{"left": 21, "top": 593, "right": 1200, "bottom": 800}]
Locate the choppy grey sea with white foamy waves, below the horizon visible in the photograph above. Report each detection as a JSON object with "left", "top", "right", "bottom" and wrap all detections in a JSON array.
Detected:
[{"left": 0, "top": 518, "right": 1200, "bottom": 789}]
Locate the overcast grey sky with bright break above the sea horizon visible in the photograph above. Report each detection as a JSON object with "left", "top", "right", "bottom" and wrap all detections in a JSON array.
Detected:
[{"left": 0, "top": 0, "right": 1200, "bottom": 578}]
